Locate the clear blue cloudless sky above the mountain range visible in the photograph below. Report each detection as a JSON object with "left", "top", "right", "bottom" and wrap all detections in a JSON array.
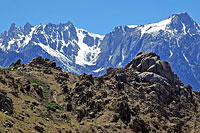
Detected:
[{"left": 0, "top": 0, "right": 200, "bottom": 34}]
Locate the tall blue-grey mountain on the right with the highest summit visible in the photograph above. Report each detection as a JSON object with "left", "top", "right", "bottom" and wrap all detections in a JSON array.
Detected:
[{"left": 97, "top": 13, "right": 200, "bottom": 89}]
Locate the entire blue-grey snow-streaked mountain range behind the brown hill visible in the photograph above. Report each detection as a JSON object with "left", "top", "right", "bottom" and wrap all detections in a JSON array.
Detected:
[{"left": 0, "top": 13, "right": 200, "bottom": 90}]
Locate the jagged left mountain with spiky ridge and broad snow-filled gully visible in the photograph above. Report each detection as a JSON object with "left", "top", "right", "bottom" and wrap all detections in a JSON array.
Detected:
[{"left": 0, "top": 22, "right": 104, "bottom": 74}]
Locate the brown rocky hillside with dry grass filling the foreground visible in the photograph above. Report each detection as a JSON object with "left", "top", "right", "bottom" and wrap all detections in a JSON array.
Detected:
[{"left": 0, "top": 53, "right": 200, "bottom": 133}]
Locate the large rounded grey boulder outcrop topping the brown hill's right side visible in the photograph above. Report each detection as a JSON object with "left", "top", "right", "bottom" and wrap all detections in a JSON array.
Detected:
[{"left": 125, "top": 52, "right": 180, "bottom": 85}]
